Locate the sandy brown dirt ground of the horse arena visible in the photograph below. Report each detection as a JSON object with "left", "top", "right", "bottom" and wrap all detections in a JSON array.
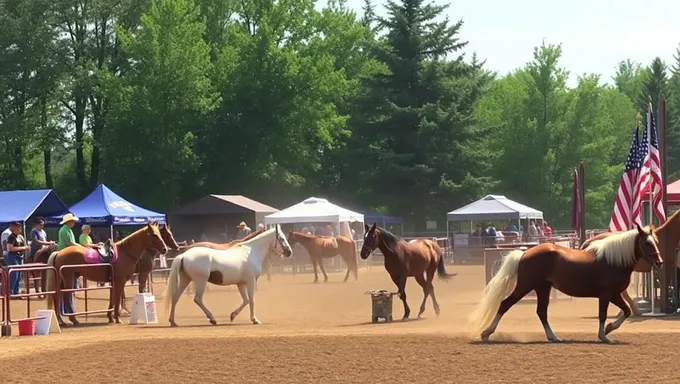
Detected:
[{"left": 0, "top": 266, "right": 680, "bottom": 384}]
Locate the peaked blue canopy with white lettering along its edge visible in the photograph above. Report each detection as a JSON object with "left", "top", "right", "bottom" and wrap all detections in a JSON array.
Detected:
[{"left": 60, "top": 184, "right": 165, "bottom": 225}]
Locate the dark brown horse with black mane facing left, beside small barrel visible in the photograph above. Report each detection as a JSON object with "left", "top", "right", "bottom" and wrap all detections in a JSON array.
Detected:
[{"left": 361, "top": 223, "right": 456, "bottom": 320}]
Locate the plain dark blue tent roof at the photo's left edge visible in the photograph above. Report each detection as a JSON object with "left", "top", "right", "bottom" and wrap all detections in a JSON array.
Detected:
[{"left": 0, "top": 189, "right": 68, "bottom": 224}]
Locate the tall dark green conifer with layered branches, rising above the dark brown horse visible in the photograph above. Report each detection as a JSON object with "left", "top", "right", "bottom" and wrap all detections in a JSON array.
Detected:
[{"left": 349, "top": 0, "right": 491, "bottom": 227}]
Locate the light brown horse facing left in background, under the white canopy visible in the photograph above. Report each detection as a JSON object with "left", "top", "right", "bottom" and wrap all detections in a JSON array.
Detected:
[{"left": 288, "top": 231, "right": 359, "bottom": 283}]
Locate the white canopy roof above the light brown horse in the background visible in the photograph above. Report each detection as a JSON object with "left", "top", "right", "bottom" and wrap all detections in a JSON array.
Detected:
[{"left": 264, "top": 197, "right": 364, "bottom": 225}]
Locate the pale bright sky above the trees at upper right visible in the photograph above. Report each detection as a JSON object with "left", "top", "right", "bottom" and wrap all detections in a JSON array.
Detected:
[{"left": 348, "top": 0, "right": 680, "bottom": 86}]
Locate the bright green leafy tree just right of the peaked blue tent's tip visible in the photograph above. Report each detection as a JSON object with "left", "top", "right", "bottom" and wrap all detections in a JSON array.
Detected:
[{"left": 102, "top": 0, "right": 216, "bottom": 207}]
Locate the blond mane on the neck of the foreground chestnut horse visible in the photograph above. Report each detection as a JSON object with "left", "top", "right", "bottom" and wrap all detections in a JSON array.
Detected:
[{"left": 585, "top": 226, "right": 651, "bottom": 267}]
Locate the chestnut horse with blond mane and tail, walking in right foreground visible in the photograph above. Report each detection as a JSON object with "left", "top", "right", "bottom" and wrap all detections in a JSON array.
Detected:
[{"left": 470, "top": 226, "right": 663, "bottom": 343}]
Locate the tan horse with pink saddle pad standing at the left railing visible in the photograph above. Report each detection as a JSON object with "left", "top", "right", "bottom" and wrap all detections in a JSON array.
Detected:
[{"left": 47, "top": 222, "right": 167, "bottom": 325}]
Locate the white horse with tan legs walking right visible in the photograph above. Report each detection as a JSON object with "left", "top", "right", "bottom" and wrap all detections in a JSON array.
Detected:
[{"left": 164, "top": 224, "right": 293, "bottom": 327}]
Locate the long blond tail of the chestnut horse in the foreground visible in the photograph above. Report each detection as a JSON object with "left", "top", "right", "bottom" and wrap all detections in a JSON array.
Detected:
[{"left": 470, "top": 250, "right": 524, "bottom": 336}]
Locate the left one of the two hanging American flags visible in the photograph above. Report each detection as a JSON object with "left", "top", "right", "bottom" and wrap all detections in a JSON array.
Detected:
[{"left": 609, "top": 128, "right": 642, "bottom": 232}]
